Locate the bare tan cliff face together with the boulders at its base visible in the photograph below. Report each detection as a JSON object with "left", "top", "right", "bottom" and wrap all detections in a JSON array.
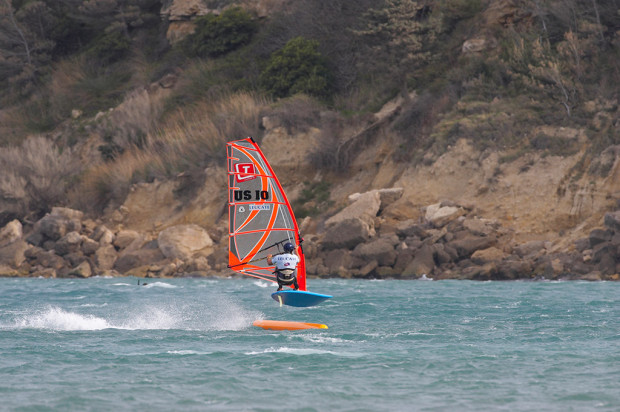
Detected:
[{"left": 0, "top": 98, "right": 620, "bottom": 280}]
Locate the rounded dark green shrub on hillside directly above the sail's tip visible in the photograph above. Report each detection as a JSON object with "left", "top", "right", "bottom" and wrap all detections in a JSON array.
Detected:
[{"left": 259, "top": 37, "right": 331, "bottom": 98}]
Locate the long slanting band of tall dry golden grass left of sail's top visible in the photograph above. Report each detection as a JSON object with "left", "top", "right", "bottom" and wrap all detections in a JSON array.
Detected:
[{"left": 72, "top": 93, "right": 269, "bottom": 211}]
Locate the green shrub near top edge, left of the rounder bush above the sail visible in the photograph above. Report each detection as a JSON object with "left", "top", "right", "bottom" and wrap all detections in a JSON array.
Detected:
[{"left": 182, "top": 7, "right": 257, "bottom": 57}]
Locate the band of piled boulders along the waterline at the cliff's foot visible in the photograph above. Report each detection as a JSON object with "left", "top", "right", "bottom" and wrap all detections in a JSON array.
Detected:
[{"left": 0, "top": 188, "right": 620, "bottom": 281}]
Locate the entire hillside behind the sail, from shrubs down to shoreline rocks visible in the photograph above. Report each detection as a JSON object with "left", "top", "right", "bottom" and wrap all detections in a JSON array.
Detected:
[{"left": 0, "top": 0, "right": 620, "bottom": 280}]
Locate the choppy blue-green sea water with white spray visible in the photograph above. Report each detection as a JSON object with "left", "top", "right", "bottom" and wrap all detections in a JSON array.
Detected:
[{"left": 0, "top": 278, "right": 620, "bottom": 412}]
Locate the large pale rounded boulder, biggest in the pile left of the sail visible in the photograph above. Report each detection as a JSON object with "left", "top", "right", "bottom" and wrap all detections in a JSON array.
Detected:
[{"left": 157, "top": 224, "right": 213, "bottom": 259}]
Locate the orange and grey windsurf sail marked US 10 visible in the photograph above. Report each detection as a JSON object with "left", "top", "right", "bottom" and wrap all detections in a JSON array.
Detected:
[{"left": 226, "top": 137, "right": 306, "bottom": 290}]
